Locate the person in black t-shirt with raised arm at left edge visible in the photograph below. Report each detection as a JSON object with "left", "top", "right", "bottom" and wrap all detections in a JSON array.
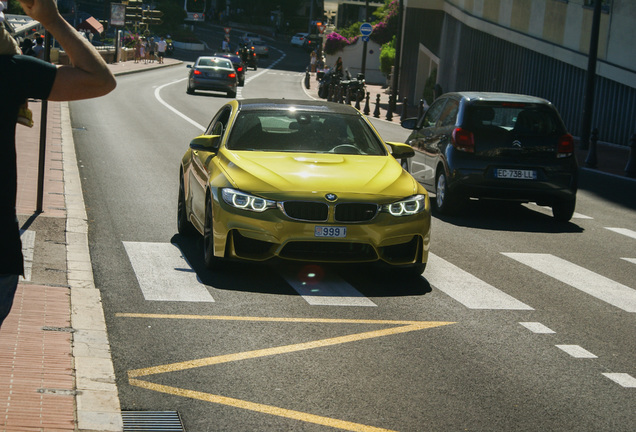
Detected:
[{"left": 0, "top": 0, "right": 116, "bottom": 326}]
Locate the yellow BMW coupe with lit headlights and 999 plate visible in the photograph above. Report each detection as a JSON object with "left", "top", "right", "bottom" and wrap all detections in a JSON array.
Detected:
[{"left": 177, "top": 99, "right": 431, "bottom": 275}]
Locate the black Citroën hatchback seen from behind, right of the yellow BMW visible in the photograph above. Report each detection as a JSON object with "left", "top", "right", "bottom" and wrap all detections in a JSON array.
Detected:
[{"left": 402, "top": 92, "right": 578, "bottom": 221}]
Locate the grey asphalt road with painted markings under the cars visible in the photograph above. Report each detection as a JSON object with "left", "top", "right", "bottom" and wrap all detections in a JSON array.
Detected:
[{"left": 71, "top": 30, "right": 636, "bottom": 432}]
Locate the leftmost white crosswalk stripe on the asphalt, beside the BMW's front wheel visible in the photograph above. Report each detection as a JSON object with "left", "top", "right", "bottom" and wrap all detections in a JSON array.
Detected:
[{"left": 123, "top": 242, "right": 214, "bottom": 302}]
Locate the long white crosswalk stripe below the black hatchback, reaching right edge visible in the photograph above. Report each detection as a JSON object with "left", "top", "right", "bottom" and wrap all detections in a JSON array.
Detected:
[{"left": 503, "top": 253, "right": 636, "bottom": 312}]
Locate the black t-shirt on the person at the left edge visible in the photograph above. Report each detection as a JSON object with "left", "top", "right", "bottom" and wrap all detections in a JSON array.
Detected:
[{"left": 0, "top": 55, "right": 57, "bottom": 274}]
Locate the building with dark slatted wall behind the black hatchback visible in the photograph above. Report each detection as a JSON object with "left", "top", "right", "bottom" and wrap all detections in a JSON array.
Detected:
[{"left": 398, "top": 0, "right": 636, "bottom": 145}]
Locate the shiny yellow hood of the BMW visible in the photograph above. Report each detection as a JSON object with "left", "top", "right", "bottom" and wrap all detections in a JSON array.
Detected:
[{"left": 219, "top": 152, "right": 421, "bottom": 199}]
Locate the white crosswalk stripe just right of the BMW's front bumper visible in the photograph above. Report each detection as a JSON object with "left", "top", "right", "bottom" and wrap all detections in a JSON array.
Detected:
[{"left": 424, "top": 253, "right": 534, "bottom": 310}]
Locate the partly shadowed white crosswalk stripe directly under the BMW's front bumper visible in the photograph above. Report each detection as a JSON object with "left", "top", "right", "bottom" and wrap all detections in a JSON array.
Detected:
[{"left": 282, "top": 266, "right": 376, "bottom": 307}]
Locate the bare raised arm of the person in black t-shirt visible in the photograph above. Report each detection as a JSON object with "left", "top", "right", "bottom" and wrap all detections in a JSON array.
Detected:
[{"left": 19, "top": 0, "right": 117, "bottom": 101}]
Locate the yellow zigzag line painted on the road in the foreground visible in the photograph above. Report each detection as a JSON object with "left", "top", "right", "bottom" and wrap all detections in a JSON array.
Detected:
[{"left": 116, "top": 313, "right": 455, "bottom": 432}]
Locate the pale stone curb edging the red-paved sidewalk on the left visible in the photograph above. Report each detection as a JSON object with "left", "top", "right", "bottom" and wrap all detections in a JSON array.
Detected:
[{"left": 61, "top": 102, "right": 123, "bottom": 432}]
